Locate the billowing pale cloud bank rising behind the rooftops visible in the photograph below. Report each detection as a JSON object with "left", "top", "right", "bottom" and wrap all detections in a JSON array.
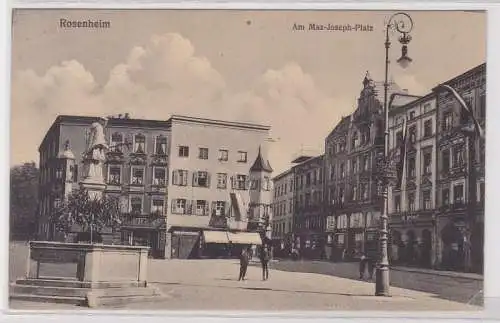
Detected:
[{"left": 12, "top": 34, "right": 352, "bottom": 175}]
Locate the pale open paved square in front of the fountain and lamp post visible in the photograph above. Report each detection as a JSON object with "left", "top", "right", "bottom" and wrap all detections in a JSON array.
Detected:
[{"left": 11, "top": 244, "right": 481, "bottom": 311}]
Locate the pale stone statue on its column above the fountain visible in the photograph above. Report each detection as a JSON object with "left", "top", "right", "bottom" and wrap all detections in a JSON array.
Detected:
[{"left": 83, "top": 118, "right": 109, "bottom": 184}]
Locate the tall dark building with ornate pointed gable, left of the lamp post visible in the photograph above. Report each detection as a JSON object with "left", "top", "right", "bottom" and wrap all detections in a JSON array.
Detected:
[{"left": 324, "top": 73, "right": 416, "bottom": 259}]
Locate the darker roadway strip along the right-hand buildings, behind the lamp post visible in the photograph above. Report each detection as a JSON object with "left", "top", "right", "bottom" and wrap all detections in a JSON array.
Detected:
[{"left": 256, "top": 260, "right": 483, "bottom": 305}]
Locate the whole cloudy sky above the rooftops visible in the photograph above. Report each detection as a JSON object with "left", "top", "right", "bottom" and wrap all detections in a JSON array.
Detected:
[{"left": 10, "top": 9, "right": 486, "bottom": 174}]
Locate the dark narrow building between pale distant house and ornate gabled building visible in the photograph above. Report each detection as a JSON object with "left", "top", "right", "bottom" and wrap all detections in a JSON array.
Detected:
[{"left": 292, "top": 155, "right": 326, "bottom": 258}]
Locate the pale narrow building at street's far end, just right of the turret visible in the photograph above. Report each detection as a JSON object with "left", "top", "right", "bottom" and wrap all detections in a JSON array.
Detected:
[{"left": 272, "top": 169, "right": 295, "bottom": 255}]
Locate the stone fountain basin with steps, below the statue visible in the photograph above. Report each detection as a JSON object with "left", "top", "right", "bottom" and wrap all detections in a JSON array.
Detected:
[{"left": 10, "top": 241, "right": 161, "bottom": 307}]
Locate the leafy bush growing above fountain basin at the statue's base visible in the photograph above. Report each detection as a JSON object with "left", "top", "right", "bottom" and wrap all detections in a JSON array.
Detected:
[{"left": 50, "top": 188, "right": 122, "bottom": 243}]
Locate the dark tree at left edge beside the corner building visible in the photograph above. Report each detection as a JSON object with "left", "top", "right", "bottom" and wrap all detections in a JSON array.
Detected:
[{"left": 10, "top": 162, "right": 39, "bottom": 239}]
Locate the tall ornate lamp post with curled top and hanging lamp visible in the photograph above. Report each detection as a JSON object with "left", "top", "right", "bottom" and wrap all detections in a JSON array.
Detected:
[{"left": 375, "top": 12, "right": 413, "bottom": 296}]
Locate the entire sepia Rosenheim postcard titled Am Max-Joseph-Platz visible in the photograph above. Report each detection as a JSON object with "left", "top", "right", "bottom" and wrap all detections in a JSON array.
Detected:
[{"left": 9, "top": 9, "right": 487, "bottom": 312}]
